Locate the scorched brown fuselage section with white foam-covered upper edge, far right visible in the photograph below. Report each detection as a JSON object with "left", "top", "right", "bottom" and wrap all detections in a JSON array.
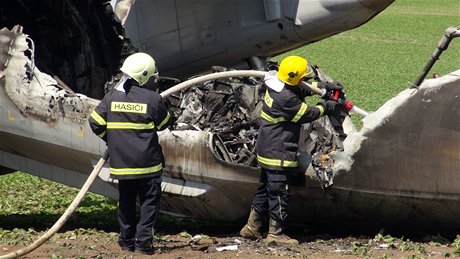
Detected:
[{"left": 316, "top": 70, "right": 460, "bottom": 233}]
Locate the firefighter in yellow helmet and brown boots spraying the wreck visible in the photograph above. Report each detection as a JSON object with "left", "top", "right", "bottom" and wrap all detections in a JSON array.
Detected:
[{"left": 240, "top": 56, "right": 337, "bottom": 245}]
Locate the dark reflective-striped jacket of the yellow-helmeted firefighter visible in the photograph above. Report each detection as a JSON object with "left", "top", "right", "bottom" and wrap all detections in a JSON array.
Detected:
[{"left": 256, "top": 76, "right": 324, "bottom": 170}]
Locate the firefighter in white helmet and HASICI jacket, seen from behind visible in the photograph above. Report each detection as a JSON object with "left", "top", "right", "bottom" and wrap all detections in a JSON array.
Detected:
[{"left": 89, "top": 53, "right": 172, "bottom": 254}]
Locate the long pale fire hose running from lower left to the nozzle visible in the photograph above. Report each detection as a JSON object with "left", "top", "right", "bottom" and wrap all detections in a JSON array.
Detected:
[{"left": 0, "top": 70, "right": 367, "bottom": 259}]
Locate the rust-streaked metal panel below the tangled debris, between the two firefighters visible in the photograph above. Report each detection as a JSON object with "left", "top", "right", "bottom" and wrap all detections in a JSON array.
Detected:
[{"left": 160, "top": 130, "right": 259, "bottom": 220}]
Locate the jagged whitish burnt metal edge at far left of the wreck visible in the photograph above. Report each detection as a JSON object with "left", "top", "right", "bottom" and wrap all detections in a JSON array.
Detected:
[{"left": 0, "top": 26, "right": 97, "bottom": 124}]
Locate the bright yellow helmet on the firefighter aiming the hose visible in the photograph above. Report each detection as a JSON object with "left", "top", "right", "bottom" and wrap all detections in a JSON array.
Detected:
[{"left": 277, "top": 56, "right": 312, "bottom": 86}]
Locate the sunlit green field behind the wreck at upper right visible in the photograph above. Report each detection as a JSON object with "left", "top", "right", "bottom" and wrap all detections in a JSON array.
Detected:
[{"left": 275, "top": 0, "right": 460, "bottom": 114}]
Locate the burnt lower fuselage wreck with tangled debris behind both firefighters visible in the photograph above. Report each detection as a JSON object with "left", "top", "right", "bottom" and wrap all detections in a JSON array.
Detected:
[{"left": 0, "top": 23, "right": 460, "bottom": 236}]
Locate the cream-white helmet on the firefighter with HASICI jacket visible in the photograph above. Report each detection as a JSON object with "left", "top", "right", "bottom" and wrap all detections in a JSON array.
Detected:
[{"left": 120, "top": 52, "right": 158, "bottom": 85}]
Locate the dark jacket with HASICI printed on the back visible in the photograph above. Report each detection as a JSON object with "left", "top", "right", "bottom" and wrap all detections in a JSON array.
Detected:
[{"left": 89, "top": 80, "right": 172, "bottom": 179}]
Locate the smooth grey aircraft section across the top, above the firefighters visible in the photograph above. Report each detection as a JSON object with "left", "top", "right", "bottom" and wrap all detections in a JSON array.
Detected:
[{"left": 121, "top": 0, "right": 393, "bottom": 77}]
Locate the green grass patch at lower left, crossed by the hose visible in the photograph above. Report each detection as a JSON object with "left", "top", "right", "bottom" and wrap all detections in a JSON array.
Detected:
[{"left": 0, "top": 172, "right": 117, "bottom": 232}]
